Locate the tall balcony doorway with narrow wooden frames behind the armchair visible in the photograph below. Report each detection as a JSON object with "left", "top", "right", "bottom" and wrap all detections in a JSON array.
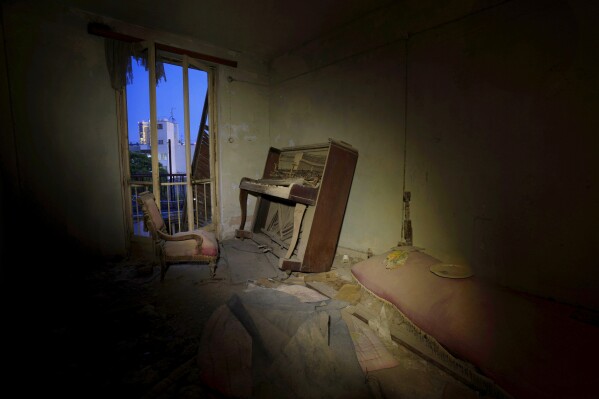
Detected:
[{"left": 123, "top": 48, "right": 216, "bottom": 253}]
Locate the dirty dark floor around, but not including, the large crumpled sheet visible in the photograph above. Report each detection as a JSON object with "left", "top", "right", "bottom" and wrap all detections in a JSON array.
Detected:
[{"left": 9, "top": 239, "right": 480, "bottom": 399}]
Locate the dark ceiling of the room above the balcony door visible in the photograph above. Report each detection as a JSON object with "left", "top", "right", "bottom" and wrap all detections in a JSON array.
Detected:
[{"left": 60, "top": 0, "right": 394, "bottom": 60}]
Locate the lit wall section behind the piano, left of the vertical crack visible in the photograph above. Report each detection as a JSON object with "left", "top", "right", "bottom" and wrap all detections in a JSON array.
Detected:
[{"left": 270, "top": 46, "right": 404, "bottom": 253}]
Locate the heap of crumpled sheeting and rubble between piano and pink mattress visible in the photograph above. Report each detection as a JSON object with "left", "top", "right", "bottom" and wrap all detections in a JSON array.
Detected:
[{"left": 198, "top": 247, "right": 488, "bottom": 399}]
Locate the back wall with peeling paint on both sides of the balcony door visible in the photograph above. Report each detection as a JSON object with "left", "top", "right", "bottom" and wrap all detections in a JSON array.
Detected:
[{"left": 2, "top": 0, "right": 269, "bottom": 256}]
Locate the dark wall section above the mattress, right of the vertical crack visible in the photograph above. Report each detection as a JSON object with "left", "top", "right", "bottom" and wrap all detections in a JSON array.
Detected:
[{"left": 406, "top": 1, "right": 599, "bottom": 307}]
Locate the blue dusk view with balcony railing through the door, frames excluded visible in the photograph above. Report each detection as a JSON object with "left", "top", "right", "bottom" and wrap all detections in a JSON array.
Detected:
[{"left": 127, "top": 59, "right": 212, "bottom": 235}]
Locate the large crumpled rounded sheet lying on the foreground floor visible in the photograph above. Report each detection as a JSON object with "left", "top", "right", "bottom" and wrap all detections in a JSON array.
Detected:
[{"left": 198, "top": 286, "right": 371, "bottom": 398}]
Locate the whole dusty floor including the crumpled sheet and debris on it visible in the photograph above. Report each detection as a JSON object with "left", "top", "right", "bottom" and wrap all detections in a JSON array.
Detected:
[{"left": 29, "top": 240, "right": 488, "bottom": 399}]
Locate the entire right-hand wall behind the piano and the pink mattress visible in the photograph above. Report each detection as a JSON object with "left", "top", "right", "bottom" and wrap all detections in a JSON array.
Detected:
[{"left": 270, "top": 1, "right": 599, "bottom": 308}]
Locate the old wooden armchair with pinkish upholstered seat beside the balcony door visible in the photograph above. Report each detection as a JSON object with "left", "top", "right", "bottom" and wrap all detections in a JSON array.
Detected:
[{"left": 137, "top": 191, "right": 219, "bottom": 281}]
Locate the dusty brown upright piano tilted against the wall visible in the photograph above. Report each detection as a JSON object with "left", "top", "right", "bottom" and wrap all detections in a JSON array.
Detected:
[{"left": 235, "top": 139, "right": 358, "bottom": 272}]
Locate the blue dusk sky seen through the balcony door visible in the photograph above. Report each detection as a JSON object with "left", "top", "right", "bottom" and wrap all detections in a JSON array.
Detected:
[{"left": 127, "top": 60, "right": 208, "bottom": 143}]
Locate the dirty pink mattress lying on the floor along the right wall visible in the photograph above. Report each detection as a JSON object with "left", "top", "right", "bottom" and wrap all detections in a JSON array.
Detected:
[{"left": 352, "top": 252, "right": 599, "bottom": 399}]
